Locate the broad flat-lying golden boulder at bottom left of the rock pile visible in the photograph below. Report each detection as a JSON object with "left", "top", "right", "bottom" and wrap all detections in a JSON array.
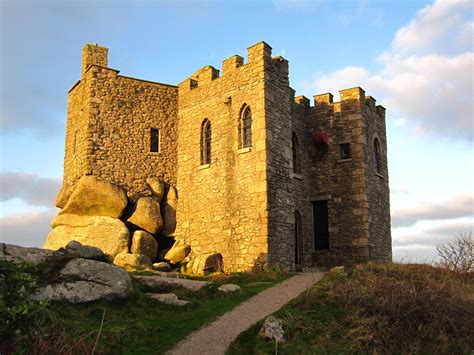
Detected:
[{"left": 43, "top": 214, "right": 130, "bottom": 260}]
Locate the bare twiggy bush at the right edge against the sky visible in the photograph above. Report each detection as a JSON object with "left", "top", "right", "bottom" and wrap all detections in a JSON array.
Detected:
[{"left": 436, "top": 232, "right": 474, "bottom": 275}]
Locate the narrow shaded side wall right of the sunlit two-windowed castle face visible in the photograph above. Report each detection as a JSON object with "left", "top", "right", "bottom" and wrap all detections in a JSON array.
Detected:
[{"left": 265, "top": 57, "right": 297, "bottom": 267}]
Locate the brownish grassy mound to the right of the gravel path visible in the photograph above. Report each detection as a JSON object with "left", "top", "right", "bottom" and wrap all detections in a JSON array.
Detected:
[{"left": 228, "top": 264, "right": 474, "bottom": 355}]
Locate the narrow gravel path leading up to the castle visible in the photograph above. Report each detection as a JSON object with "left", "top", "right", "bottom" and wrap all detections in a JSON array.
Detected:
[{"left": 167, "top": 272, "right": 323, "bottom": 355}]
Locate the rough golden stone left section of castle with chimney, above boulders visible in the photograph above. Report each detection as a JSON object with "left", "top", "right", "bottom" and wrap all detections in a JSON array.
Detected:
[{"left": 64, "top": 45, "right": 178, "bottom": 196}]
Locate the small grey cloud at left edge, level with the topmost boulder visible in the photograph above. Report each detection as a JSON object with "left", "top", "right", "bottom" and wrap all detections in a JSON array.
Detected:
[{"left": 0, "top": 171, "right": 61, "bottom": 207}]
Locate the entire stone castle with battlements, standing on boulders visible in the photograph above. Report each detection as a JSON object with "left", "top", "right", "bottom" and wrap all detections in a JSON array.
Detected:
[{"left": 55, "top": 42, "right": 392, "bottom": 271}]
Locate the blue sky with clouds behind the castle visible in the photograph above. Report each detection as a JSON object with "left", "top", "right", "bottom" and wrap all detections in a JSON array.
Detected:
[{"left": 0, "top": 0, "right": 474, "bottom": 262}]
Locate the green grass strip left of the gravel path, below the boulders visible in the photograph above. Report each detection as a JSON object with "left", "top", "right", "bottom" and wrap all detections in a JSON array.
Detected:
[{"left": 29, "top": 270, "right": 289, "bottom": 354}]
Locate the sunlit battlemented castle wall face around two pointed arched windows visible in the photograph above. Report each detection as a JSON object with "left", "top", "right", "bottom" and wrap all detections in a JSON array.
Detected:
[{"left": 175, "top": 42, "right": 271, "bottom": 271}]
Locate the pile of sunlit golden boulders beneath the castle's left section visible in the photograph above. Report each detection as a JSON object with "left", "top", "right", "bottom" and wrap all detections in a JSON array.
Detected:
[{"left": 44, "top": 175, "right": 223, "bottom": 275}]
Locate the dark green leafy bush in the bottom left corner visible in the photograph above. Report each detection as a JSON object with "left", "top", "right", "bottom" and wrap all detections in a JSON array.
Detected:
[{"left": 0, "top": 259, "right": 53, "bottom": 353}]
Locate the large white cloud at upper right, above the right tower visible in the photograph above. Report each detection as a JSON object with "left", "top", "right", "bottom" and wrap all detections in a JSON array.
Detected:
[{"left": 303, "top": 1, "right": 474, "bottom": 140}]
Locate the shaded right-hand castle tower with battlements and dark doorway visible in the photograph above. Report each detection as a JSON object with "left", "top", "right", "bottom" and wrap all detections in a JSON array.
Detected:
[{"left": 284, "top": 87, "right": 391, "bottom": 265}]
